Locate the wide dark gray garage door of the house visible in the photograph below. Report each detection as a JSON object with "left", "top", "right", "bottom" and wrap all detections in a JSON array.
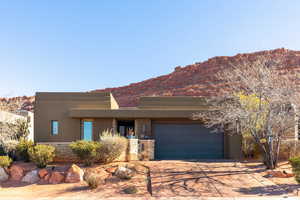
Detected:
[{"left": 153, "top": 124, "right": 224, "bottom": 160}]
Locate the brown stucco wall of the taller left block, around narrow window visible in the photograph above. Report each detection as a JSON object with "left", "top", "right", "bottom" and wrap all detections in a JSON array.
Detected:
[{"left": 34, "top": 93, "right": 115, "bottom": 142}]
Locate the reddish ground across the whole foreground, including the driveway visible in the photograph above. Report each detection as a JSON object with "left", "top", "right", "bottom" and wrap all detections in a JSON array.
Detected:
[{"left": 0, "top": 161, "right": 300, "bottom": 199}]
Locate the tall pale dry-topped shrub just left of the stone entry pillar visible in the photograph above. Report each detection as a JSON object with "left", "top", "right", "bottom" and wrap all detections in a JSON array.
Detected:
[{"left": 97, "top": 130, "right": 128, "bottom": 163}]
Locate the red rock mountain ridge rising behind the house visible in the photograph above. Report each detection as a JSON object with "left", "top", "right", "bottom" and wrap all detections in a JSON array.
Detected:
[{"left": 0, "top": 48, "right": 300, "bottom": 110}]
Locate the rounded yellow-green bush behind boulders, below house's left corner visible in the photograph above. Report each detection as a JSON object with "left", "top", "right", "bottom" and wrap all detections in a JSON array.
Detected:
[{"left": 28, "top": 144, "right": 55, "bottom": 168}]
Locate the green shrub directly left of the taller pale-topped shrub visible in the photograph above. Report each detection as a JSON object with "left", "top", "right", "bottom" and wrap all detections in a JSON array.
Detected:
[{"left": 69, "top": 140, "right": 101, "bottom": 166}]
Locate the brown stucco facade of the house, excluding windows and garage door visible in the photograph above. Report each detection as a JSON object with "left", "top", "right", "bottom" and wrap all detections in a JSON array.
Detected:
[{"left": 34, "top": 93, "right": 241, "bottom": 159}]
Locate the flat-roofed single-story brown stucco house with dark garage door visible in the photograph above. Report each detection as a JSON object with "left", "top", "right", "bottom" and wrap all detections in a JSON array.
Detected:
[{"left": 34, "top": 92, "right": 241, "bottom": 159}]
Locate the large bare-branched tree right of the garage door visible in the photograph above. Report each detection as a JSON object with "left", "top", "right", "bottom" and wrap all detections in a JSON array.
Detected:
[{"left": 193, "top": 56, "right": 299, "bottom": 169}]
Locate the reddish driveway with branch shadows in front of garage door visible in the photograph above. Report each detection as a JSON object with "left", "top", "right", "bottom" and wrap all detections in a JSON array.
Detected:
[{"left": 145, "top": 161, "right": 300, "bottom": 197}]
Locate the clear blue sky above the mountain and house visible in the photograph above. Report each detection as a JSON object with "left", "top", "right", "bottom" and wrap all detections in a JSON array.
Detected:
[{"left": 0, "top": 0, "right": 300, "bottom": 96}]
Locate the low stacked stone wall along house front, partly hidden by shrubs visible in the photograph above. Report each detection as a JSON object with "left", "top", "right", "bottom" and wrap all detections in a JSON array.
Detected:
[{"left": 39, "top": 139, "right": 154, "bottom": 162}]
